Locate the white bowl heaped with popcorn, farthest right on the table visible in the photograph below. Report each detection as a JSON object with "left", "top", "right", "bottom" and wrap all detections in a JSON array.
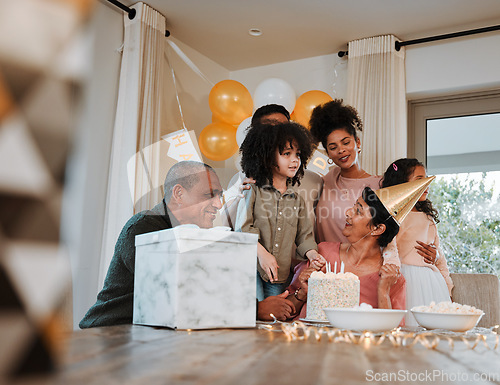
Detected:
[{"left": 411, "top": 301, "right": 484, "bottom": 332}]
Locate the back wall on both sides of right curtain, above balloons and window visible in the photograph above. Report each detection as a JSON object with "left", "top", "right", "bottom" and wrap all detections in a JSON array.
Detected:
[{"left": 230, "top": 32, "right": 500, "bottom": 103}]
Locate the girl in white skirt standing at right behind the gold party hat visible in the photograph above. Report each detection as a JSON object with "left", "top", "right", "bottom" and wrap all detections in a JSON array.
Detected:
[{"left": 382, "top": 158, "right": 453, "bottom": 326}]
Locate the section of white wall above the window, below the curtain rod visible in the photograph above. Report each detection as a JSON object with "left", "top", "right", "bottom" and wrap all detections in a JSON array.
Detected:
[{"left": 406, "top": 32, "right": 500, "bottom": 99}]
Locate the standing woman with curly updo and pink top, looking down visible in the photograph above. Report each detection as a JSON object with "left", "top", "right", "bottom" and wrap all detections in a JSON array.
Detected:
[{"left": 309, "top": 99, "right": 380, "bottom": 243}]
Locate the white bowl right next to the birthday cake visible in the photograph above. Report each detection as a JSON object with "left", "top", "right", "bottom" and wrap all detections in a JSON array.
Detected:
[{"left": 323, "top": 308, "right": 406, "bottom": 332}]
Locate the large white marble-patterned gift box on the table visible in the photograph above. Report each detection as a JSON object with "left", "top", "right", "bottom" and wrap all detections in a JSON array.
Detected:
[{"left": 133, "top": 225, "right": 258, "bottom": 329}]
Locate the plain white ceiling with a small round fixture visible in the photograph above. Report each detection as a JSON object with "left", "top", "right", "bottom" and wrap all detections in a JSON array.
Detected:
[{"left": 122, "top": 0, "right": 500, "bottom": 71}]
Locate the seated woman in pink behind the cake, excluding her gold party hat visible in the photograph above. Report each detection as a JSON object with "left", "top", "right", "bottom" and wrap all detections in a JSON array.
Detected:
[{"left": 287, "top": 187, "right": 406, "bottom": 318}]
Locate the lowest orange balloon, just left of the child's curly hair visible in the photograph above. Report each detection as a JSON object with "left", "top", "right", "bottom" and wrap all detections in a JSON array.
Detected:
[{"left": 198, "top": 122, "right": 238, "bottom": 161}]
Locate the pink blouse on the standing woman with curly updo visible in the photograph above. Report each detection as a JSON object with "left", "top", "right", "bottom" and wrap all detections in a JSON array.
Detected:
[{"left": 315, "top": 167, "right": 380, "bottom": 243}]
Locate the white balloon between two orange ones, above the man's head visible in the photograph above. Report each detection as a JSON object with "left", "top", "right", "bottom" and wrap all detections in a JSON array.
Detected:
[{"left": 253, "top": 78, "right": 295, "bottom": 113}]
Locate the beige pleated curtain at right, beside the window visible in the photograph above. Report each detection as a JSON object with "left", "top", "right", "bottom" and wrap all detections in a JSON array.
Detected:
[{"left": 346, "top": 35, "right": 407, "bottom": 175}]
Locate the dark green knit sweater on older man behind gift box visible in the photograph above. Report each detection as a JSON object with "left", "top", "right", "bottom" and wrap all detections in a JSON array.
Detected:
[{"left": 79, "top": 200, "right": 177, "bottom": 329}]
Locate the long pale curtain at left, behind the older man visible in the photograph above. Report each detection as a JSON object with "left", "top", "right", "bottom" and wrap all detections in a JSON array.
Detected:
[{"left": 99, "top": 3, "right": 167, "bottom": 288}]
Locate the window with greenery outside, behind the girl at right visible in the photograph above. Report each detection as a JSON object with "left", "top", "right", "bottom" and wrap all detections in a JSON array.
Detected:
[{"left": 408, "top": 91, "right": 500, "bottom": 274}]
